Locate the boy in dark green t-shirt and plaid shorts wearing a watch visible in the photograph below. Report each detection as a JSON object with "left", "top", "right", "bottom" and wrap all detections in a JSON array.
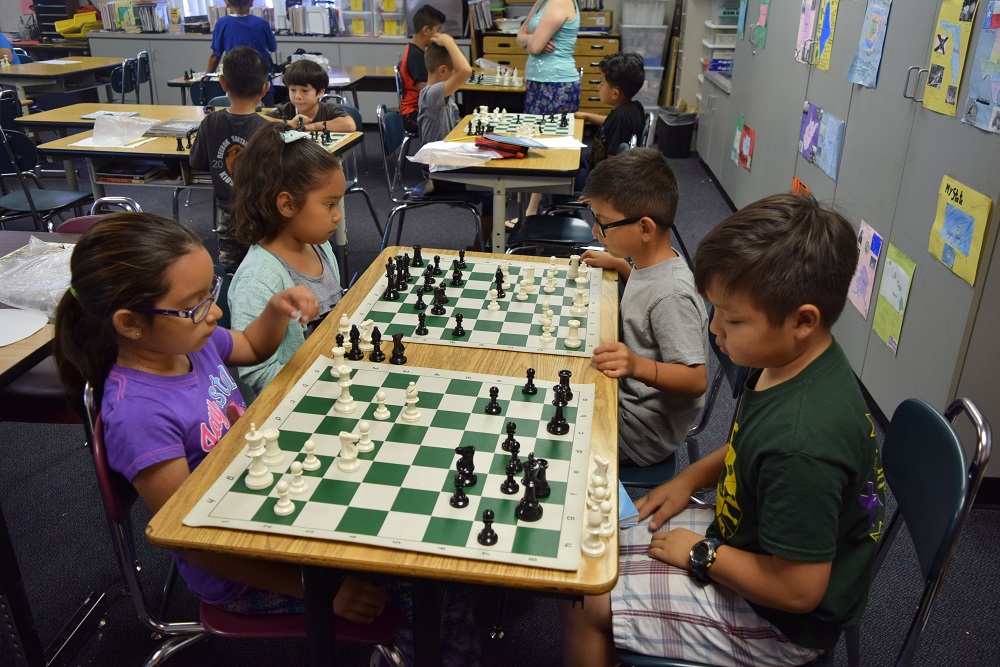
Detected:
[{"left": 562, "top": 194, "right": 885, "bottom": 665}]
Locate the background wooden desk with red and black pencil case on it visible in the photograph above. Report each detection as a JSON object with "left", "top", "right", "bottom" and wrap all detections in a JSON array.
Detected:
[{"left": 442, "top": 116, "right": 584, "bottom": 253}]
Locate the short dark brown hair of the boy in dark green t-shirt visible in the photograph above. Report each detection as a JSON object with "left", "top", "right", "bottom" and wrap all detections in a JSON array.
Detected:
[{"left": 694, "top": 193, "right": 858, "bottom": 328}]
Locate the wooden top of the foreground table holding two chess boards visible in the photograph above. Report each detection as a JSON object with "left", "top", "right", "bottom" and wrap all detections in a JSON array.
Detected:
[{"left": 146, "top": 247, "right": 618, "bottom": 595}]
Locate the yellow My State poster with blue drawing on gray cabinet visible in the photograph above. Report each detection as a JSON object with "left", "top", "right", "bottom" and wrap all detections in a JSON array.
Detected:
[{"left": 927, "top": 176, "right": 993, "bottom": 285}]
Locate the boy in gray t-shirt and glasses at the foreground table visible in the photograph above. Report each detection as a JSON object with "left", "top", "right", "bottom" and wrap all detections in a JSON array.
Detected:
[{"left": 582, "top": 148, "right": 708, "bottom": 466}]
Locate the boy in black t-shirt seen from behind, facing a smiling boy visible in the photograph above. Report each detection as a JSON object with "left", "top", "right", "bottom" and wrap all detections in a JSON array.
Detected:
[{"left": 189, "top": 46, "right": 271, "bottom": 273}]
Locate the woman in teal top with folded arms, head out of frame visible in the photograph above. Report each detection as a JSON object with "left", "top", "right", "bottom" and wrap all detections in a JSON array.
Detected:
[{"left": 517, "top": 0, "right": 580, "bottom": 114}]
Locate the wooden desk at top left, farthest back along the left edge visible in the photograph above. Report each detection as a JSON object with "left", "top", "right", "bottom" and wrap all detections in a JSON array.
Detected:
[{"left": 0, "top": 56, "right": 122, "bottom": 99}]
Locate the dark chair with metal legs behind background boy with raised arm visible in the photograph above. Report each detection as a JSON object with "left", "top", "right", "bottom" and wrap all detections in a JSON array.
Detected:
[{"left": 376, "top": 104, "right": 483, "bottom": 250}]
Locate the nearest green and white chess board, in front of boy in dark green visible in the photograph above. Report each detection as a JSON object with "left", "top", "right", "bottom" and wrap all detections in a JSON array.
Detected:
[{"left": 184, "top": 357, "right": 594, "bottom": 571}]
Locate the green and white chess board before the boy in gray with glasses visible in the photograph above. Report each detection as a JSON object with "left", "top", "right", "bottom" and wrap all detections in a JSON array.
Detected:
[{"left": 352, "top": 254, "right": 601, "bottom": 357}]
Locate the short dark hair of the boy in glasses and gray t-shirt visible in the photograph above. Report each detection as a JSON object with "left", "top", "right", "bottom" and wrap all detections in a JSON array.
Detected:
[{"left": 583, "top": 148, "right": 678, "bottom": 227}]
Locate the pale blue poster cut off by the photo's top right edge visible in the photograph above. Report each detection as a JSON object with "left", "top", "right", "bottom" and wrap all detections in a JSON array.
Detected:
[{"left": 962, "top": 1, "right": 1000, "bottom": 133}]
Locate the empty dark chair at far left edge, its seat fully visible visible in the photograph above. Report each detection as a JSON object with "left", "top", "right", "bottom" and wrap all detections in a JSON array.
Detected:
[{"left": 0, "top": 128, "right": 93, "bottom": 232}]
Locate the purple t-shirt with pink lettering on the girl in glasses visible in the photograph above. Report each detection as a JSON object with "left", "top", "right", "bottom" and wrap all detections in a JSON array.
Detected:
[{"left": 101, "top": 328, "right": 247, "bottom": 604}]
